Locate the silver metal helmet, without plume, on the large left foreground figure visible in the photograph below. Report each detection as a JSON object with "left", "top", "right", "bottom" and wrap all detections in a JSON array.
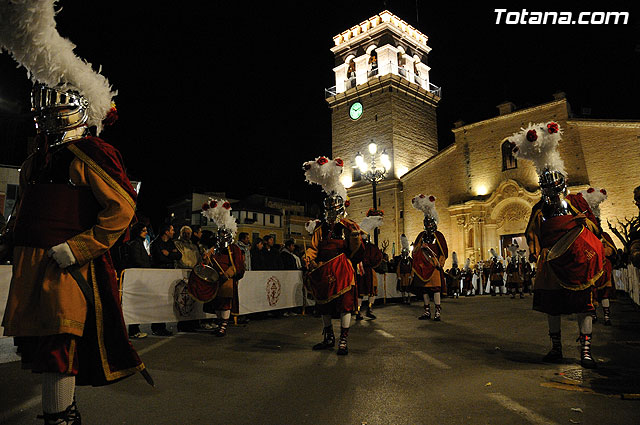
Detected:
[{"left": 31, "top": 84, "right": 89, "bottom": 144}]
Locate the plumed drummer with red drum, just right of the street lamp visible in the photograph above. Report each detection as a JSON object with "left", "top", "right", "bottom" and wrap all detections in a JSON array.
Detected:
[{"left": 410, "top": 194, "right": 449, "bottom": 321}]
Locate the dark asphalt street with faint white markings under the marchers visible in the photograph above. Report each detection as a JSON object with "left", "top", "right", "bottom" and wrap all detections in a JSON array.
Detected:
[{"left": 0, "top": 296, "right": 640, "bottom": 425}]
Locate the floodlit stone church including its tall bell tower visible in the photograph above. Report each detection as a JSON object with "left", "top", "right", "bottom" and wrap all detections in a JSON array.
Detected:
[{"left": 327, "top": 11, "right": 640, "bottom": 265}]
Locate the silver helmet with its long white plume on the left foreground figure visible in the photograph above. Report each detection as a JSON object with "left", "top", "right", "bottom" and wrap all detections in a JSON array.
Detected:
[{"left": 0, "top": 0, "right": 116, "bottom": 134}]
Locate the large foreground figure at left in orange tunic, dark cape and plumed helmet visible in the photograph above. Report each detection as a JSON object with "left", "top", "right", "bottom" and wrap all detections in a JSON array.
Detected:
[{"left": 0, "top": 1, "right": 153, "bottom": 424}]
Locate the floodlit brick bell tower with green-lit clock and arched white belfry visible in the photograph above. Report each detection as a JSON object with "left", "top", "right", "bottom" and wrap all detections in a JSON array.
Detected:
[{"left": 325, "top": 10, "right": 441, "bottom": 252}]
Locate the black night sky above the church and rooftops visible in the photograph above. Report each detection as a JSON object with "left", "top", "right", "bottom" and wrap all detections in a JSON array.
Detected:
[{"left": 0, "top": 0, "right": 640, "bottom": 227}]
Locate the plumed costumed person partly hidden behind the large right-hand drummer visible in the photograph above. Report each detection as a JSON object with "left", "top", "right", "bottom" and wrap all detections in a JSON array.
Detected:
[{"left": 579, "top": 187, "right": 618, "bottom": 326}]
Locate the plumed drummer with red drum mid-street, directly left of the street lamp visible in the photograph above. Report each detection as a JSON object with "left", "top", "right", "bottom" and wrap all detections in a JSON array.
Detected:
[{"left": 303, "top": 156, "right": 364, "bottom": 355}]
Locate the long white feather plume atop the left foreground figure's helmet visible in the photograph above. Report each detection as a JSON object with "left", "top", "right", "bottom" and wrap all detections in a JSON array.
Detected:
[{"left": 0, "top": 0, "right": 117, "bottom": 134}]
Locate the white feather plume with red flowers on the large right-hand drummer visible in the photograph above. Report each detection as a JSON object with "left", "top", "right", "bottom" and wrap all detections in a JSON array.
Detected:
[{"left": 509, "top": 121, "right": 566, "bottom": 176}]
